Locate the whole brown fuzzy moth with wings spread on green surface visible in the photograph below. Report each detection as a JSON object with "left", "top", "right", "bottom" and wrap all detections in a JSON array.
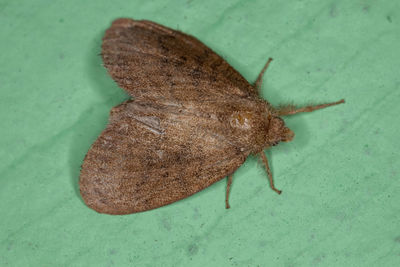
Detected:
[{"left": 80, "top": 19, "right": 344, "bottom": 214}]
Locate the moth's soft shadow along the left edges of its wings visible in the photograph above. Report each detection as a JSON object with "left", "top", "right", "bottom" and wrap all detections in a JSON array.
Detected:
[{"left": 69, "top": 31, "right": 129, "bottom": 199}]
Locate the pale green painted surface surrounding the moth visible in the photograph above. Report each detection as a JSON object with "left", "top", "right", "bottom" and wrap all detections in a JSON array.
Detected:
[{"left": 0, "top": 0, "right": 400, "bottom": 266}]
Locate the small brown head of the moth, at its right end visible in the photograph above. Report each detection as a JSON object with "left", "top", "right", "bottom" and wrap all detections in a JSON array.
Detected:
[{"left": 266, "top": 115, "right": 294, "bottom": 146}]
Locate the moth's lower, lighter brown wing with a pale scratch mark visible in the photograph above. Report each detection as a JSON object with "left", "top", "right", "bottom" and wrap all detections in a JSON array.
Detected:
[{"left": 80, "top": 100, "right": 246, "bottom": 214}]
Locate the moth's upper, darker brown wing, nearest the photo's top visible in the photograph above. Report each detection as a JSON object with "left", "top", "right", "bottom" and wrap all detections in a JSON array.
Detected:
[{"left": 102, "top": 19, "right": 257, "bottom": 101}]
